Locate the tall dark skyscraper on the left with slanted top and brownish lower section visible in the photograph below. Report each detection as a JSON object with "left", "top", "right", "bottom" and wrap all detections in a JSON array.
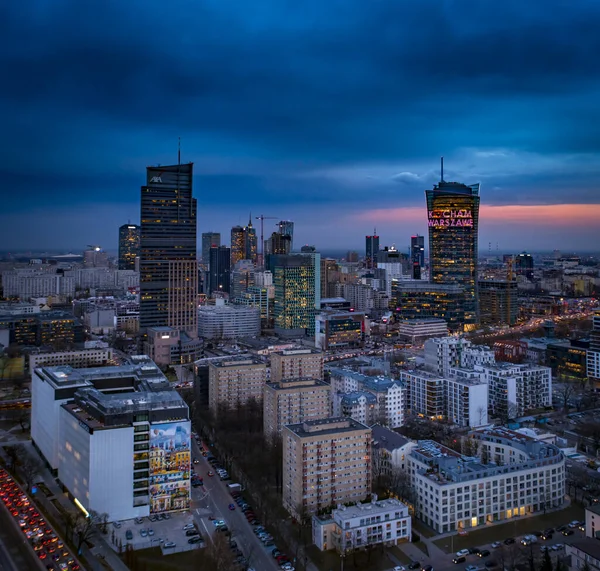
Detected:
[{"left": 140, "top": 163, "right": 198, "bottom": 339}]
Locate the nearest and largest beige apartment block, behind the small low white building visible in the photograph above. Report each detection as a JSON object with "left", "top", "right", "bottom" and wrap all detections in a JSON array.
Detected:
[{"left": 282, "top": 417, "right": 371, "bottom": 518}]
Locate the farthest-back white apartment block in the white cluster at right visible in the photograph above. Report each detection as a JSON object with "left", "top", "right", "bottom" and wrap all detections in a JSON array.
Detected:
[{"left": 425, "top": 337, "right": 496, "bottom": 377}]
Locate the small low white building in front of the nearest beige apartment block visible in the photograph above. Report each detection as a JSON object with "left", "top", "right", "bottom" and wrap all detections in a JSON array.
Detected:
[{"left": 312, "top": 498, "right": 412, "bottom": 553}]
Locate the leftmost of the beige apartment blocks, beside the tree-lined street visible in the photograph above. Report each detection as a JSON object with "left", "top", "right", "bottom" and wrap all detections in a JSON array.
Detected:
[{"left": 208, "top": 355, "right": 267, "bottom": 412}]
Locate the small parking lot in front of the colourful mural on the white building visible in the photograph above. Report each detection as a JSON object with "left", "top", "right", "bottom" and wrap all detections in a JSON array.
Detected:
[{"left": 109, "top": 511, "right": 204, "bottom": 553}]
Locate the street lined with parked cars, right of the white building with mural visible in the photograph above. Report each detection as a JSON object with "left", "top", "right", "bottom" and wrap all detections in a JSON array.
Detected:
[{"left": 192, "top": 440, "right": 280, "bottom": 571}]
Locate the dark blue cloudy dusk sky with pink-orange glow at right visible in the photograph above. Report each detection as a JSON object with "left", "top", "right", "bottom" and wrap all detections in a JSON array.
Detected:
[{"left": 0, "top": 0, "right": 600, "bottom": 255}]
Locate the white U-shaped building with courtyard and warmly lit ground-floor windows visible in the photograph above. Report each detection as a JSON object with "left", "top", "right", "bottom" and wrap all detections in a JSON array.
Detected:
[{"left": 408, "top": 427, "right": 565, "bottom": 533}]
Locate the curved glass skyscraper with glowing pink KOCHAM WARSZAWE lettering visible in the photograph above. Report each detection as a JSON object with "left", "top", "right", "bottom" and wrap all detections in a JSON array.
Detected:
[{"left": 425, "top": 163, "right": 480, "bottom": 329}]
